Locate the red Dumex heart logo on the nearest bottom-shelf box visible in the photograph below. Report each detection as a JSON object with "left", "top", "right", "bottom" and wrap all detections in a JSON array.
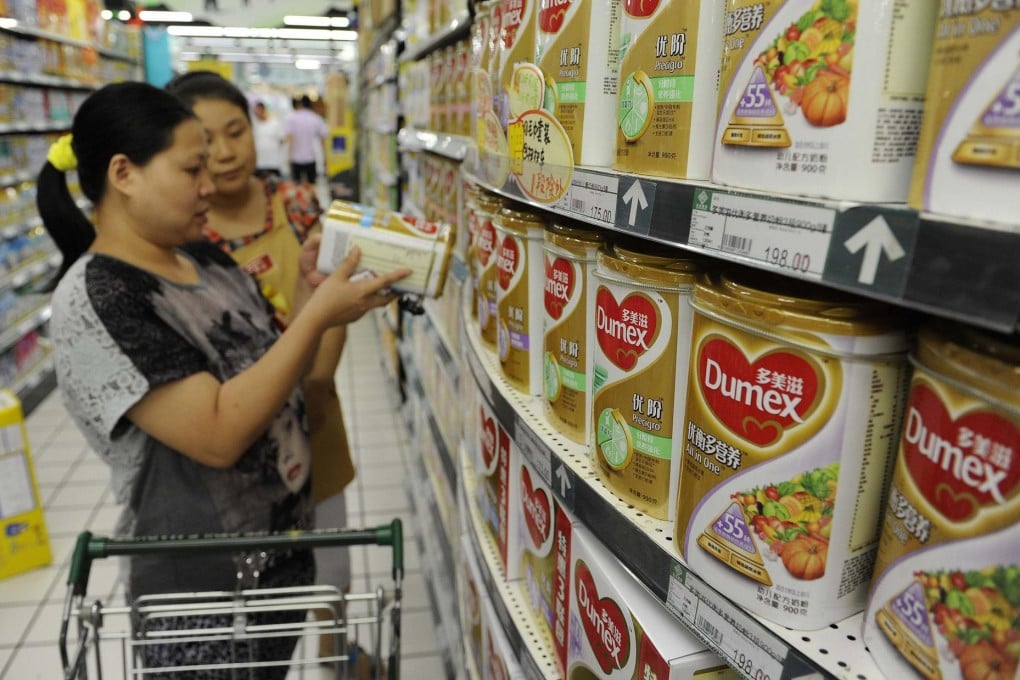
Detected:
[{"left": 574, "top": 560, "right": 630, "bottom": 675}]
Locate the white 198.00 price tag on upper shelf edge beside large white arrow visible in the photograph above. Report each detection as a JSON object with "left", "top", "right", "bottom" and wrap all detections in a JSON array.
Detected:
[{"left": 689, "top": 189, "right": 836, "bottom": 279}]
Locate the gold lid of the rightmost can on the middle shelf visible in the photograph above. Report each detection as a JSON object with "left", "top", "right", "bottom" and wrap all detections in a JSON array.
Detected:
[{"left": 917, "top": 321, "right": 1020, "bottom": 409}]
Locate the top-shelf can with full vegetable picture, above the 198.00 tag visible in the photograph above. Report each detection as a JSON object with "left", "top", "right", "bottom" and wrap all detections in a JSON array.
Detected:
[{"left": 712, "top": 0, "right": 945, "bottom": 202}]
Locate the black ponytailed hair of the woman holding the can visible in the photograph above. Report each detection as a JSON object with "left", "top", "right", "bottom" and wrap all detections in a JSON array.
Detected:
[{"left": 36, "top": 83, "right": 195, "bottom": 280}]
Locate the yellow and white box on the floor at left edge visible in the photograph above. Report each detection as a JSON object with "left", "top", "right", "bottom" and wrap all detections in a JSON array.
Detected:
[{"left": 0, "top": 389, "right": 52, "bottom": 578}]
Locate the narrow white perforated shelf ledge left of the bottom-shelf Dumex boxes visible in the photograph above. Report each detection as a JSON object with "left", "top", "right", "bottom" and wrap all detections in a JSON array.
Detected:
[{"left": 460, "top": 451, "right": 560, "bottom": 679}]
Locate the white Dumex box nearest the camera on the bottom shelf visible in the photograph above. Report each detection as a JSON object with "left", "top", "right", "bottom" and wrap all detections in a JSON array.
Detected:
[{"left": 566, "top": 525, "right": 736, "bottom": 680}]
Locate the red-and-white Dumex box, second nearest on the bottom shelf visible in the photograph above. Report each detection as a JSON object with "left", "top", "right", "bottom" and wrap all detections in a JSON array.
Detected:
[{"left": 508, "top": 446, "right": 573, "bottom": 676}]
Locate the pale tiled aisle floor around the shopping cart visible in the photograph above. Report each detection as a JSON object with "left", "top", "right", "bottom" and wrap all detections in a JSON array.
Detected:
[{"left": 0, "top": 318, "right": 443, "bottom": 680}]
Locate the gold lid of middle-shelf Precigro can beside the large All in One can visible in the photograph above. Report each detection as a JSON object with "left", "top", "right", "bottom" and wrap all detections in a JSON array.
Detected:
[{"left": 597, "top": 240, "right": 704, "bottom": 287}]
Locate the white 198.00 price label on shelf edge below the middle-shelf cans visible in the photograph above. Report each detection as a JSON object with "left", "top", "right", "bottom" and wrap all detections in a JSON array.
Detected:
[{"left": 666, "top": 563, "right": 822, "bottom": 680}]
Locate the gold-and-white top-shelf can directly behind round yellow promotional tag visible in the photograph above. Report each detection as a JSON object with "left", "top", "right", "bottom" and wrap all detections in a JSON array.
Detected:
[{"left": 537, "top": 0, "right": 620, "bottom": 166}]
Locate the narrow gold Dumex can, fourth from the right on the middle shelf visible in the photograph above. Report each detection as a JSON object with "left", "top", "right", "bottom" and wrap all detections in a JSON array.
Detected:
[{"left": 542, "top": 222, "right": 602, "bottom": 443}]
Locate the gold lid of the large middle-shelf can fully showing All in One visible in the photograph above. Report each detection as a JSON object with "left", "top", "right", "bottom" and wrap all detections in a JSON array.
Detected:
[{"left": 694, "top": 269, "right": 903, "bottom": 335}]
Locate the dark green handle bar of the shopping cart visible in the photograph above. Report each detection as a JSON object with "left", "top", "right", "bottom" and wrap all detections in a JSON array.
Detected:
[{"left": 67, "top": 519, "right": 404, "bottom": 595}]
